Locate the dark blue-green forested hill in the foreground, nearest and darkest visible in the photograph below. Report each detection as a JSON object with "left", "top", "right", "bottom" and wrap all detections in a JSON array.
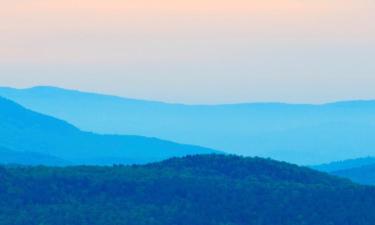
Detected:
[{"left": 0, "top": 155, "right": 375, "bottom": 225}]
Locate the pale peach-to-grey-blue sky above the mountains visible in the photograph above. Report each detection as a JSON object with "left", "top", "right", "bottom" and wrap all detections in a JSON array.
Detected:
[{"left": 0, "top": 0, "right": 375, "bottom": 104}]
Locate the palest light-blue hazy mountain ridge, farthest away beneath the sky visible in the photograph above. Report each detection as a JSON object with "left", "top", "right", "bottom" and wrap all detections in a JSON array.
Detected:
[{"left": 0, "top": 87, "right": 375, "bottom": 164}]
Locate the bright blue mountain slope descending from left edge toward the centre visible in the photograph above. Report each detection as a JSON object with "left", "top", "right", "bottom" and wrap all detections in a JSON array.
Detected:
[{"left": 0, "top": 98, "right": 214, "bottom": 164}]
